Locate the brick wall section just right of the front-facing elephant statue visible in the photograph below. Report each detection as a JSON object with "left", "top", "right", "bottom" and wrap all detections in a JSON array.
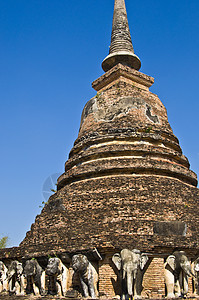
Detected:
[{"left": 142, "top": 258, "right": 165, "bottom": 298}]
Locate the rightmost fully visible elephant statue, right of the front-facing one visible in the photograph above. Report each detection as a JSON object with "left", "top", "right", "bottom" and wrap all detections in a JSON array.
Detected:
[{"left": 164, "top": 251, "right": 194, "bottom": 298}]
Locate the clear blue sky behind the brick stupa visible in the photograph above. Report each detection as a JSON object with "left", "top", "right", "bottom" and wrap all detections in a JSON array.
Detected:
[{"left": 0, "top": 0, "right": 199, "bottom": 246}]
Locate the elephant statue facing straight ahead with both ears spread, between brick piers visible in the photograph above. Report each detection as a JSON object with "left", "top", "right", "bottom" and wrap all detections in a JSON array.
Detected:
[{"left": 112, "top": 249, "right": 148, "bottom": 296}]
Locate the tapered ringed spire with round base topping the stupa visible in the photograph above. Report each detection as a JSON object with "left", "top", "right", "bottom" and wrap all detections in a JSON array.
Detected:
[{"left": 102, "top": 0, "right": 141, "bottom": 72}]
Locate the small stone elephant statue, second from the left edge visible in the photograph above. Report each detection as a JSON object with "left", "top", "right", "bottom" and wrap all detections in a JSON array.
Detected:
[{"left": 8, "top": 260, "right": 24, "bottom": 296}]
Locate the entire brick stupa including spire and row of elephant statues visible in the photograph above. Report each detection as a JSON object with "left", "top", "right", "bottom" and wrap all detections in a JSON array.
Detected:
[{"left": 0, "top": 0, "right": 199, "bottom": 299}]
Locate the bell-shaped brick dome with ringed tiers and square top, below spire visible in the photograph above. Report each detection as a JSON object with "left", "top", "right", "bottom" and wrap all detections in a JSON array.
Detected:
[{"left": 58, "top": 64, "right": 197, "bottom": 189}]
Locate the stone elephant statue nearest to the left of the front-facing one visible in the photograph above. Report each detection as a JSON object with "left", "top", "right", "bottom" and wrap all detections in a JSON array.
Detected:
[{"left": 72, "top": 254, "right": 98, "bottom": 299}]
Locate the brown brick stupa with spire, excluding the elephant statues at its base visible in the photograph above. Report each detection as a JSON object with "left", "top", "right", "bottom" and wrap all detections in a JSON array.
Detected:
[{"left": 1, "top": 0, "right": 199, "bottom": 297}]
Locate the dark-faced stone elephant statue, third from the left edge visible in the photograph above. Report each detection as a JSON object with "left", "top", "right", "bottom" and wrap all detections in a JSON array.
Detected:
[{"left": 24, "top": 259, "right": 45, "bottom": 296}]
